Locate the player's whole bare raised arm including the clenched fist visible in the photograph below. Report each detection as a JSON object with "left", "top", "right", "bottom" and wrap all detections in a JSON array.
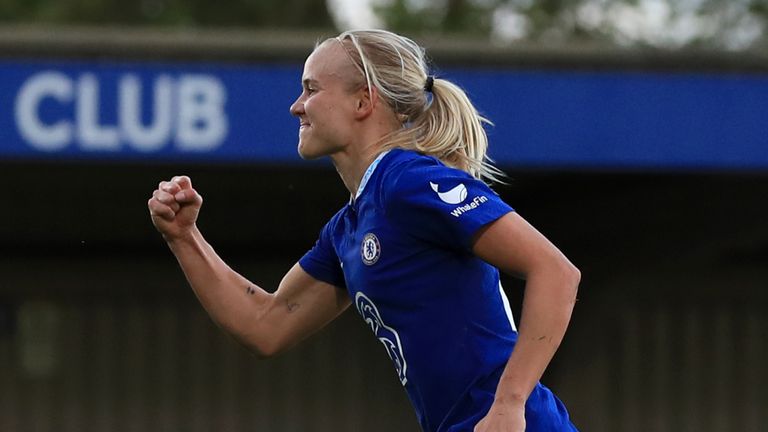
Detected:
[{"left": 148, "top": 176, "right": 350, "bottom": 356}]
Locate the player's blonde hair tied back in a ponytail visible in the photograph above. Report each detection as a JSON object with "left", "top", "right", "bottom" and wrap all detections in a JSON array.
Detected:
[{"left": 328, "top": 30, "right": 504, "bottom": 182}]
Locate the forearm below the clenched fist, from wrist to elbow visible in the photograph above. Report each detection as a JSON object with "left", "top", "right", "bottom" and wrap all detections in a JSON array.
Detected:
[{"left": 166, "top": 227, "right": 272, "bottom": 351}]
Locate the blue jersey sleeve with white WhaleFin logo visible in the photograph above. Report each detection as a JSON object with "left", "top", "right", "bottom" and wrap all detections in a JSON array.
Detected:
[{"left": 384, "top": 160, "right": 514, "bottom": 251}]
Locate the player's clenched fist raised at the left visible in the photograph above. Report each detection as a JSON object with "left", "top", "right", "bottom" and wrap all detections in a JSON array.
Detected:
[{"left": 147, "top": 176, "right": 203, "bottom": 241}]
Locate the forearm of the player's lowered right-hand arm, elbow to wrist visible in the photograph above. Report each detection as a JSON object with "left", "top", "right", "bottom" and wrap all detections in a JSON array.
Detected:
[{"left": 496, "top": 268, "right": 579, "bottom": 403}]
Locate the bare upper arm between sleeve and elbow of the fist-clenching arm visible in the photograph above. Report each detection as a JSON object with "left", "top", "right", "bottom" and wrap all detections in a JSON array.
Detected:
[{"left": 259, "top": 264, "right": 351, "bottom": 353}]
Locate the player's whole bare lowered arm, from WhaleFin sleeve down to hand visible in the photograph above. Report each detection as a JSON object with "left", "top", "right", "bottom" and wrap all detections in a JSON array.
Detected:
[{"left": 474, "top": 213, "right": 581, "bottom": 432}]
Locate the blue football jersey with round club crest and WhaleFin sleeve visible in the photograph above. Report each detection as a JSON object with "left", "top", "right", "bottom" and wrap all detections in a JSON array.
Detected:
[{"left": 299, "top": 149, "right": 571, "bottom": 431}]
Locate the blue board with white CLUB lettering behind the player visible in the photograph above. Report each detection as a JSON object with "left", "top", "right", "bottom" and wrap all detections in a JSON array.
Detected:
[{"left": 0, "top": 60, "right": 768, "bottom": 170}]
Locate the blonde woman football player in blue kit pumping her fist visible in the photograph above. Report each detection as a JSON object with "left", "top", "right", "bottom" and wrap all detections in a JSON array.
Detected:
[{"left": 148, "top": 30, "right": 580, "bottom": 432}]
